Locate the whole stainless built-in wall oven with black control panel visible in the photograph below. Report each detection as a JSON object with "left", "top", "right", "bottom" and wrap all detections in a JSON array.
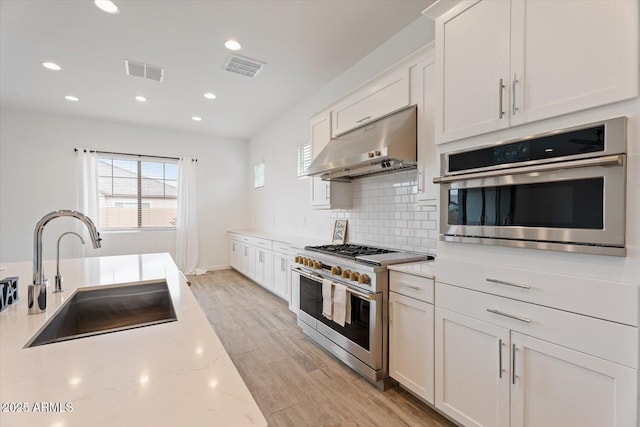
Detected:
[{"left": 434, "top": 117, "right": 626, "bottom": 256}]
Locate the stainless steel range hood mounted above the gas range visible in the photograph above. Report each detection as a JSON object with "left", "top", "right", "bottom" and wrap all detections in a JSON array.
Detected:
[{"left": 307, "top": 105, "right": 417, "bottom": 181}]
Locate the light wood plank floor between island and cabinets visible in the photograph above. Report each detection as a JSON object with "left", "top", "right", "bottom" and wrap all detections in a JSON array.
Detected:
[{"left": 189, "top": 270, "right": 453, "bottom": 427}]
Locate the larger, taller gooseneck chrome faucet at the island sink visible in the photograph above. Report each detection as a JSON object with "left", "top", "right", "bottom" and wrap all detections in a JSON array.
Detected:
[{"left": 27, "top": 210, "right": 102, "bottom": 314}]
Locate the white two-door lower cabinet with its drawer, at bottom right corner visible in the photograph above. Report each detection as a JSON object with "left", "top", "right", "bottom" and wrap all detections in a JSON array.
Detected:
[{"left": 435, "top": 283, "right": 638, "bottom": 427}]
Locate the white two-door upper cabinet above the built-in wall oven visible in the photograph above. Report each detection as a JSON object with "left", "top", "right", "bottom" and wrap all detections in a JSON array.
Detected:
[{"left": 436, "top": 0, "right": 639, "bottom": 143}]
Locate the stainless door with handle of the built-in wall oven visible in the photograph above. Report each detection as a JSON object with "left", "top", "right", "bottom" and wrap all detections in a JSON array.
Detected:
[{"left": 440, "top": 155, "right": 626, "bottom": 256}]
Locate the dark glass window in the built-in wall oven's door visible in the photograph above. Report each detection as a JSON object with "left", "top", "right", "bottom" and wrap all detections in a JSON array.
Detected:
[{"left": 448, "top": 177, "right": 604, "bottom": 230}]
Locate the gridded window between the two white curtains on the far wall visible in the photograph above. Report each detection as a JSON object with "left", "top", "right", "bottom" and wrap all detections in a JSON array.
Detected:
[{"left": 98, "top": 155, "right": 178, "bottom": 230}]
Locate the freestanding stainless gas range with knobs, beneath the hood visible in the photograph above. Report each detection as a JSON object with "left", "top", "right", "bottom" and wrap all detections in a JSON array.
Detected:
[{"left": 292, "top": 244, "right": 433, "bottom": 389}]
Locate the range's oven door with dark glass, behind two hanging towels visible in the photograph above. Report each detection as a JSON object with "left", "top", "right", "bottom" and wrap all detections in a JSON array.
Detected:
[{"left": 293, "top": 268, "right": 384, "bottom": 370}]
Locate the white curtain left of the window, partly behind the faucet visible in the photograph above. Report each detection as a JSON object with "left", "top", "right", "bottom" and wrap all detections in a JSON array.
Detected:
[{"left": 75, "top": 149, "right": 100, "bottom": 256}]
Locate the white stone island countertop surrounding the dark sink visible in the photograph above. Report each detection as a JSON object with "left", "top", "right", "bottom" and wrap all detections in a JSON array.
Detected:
[{"left": 0, "top": 254, "right": 267, "bottom": 427}]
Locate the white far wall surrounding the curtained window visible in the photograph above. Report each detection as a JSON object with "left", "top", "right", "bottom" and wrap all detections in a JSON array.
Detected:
[{"left": 0, "top": 108, "right": 249, "bottom": 268}]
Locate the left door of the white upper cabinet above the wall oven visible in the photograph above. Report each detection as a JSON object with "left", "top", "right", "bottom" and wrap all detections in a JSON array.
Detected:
[{"left": 436, "top": 0, "right": 510, "bottom": 143}]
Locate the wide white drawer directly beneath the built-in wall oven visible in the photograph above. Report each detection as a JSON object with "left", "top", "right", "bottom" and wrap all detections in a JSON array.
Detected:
[{"left": 436, "top": 258, "right": 640, "bottom": 326}]
